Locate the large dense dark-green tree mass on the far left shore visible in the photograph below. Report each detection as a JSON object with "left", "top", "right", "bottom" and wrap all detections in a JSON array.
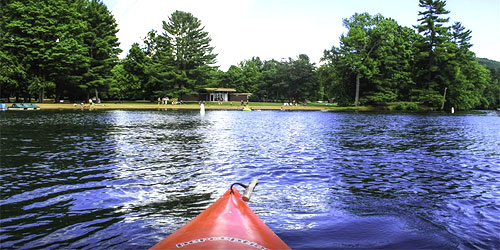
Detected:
[{"left": 0, "top": 0, "right": 121, "bottom": 100}]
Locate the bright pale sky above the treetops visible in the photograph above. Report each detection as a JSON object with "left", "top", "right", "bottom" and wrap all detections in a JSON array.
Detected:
[{"left": 103, "top": 0, "right": 500, "bottom": 71}]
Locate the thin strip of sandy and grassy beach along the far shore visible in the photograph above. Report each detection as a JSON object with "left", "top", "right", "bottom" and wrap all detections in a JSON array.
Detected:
[{"left": 33, "top": 101, "right": 423, "bottom": 111}]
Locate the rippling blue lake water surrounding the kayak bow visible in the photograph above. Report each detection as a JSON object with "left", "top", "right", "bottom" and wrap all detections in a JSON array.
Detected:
[{"left": 0, "top": 110, "right": 500, "bottom": 249}]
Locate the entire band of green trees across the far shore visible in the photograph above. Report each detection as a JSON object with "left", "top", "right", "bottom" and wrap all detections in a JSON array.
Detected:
[{"left": 0, "top": 0, "right": 500, "bottom": 110}]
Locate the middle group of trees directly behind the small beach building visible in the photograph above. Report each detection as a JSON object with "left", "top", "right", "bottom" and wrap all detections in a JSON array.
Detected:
[{"left": 110, "top": 11, "right": 319, "bottom": 101}]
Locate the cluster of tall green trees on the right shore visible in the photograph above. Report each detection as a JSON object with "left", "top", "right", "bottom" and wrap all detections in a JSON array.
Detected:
[{"left": 318, "top": 0, "right": 500, "bottom": 110}]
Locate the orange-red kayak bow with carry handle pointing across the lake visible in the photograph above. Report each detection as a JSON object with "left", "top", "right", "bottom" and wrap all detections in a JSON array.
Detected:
[{"left": 150, "top": 179, "right": 291, "bottom": 250}]
